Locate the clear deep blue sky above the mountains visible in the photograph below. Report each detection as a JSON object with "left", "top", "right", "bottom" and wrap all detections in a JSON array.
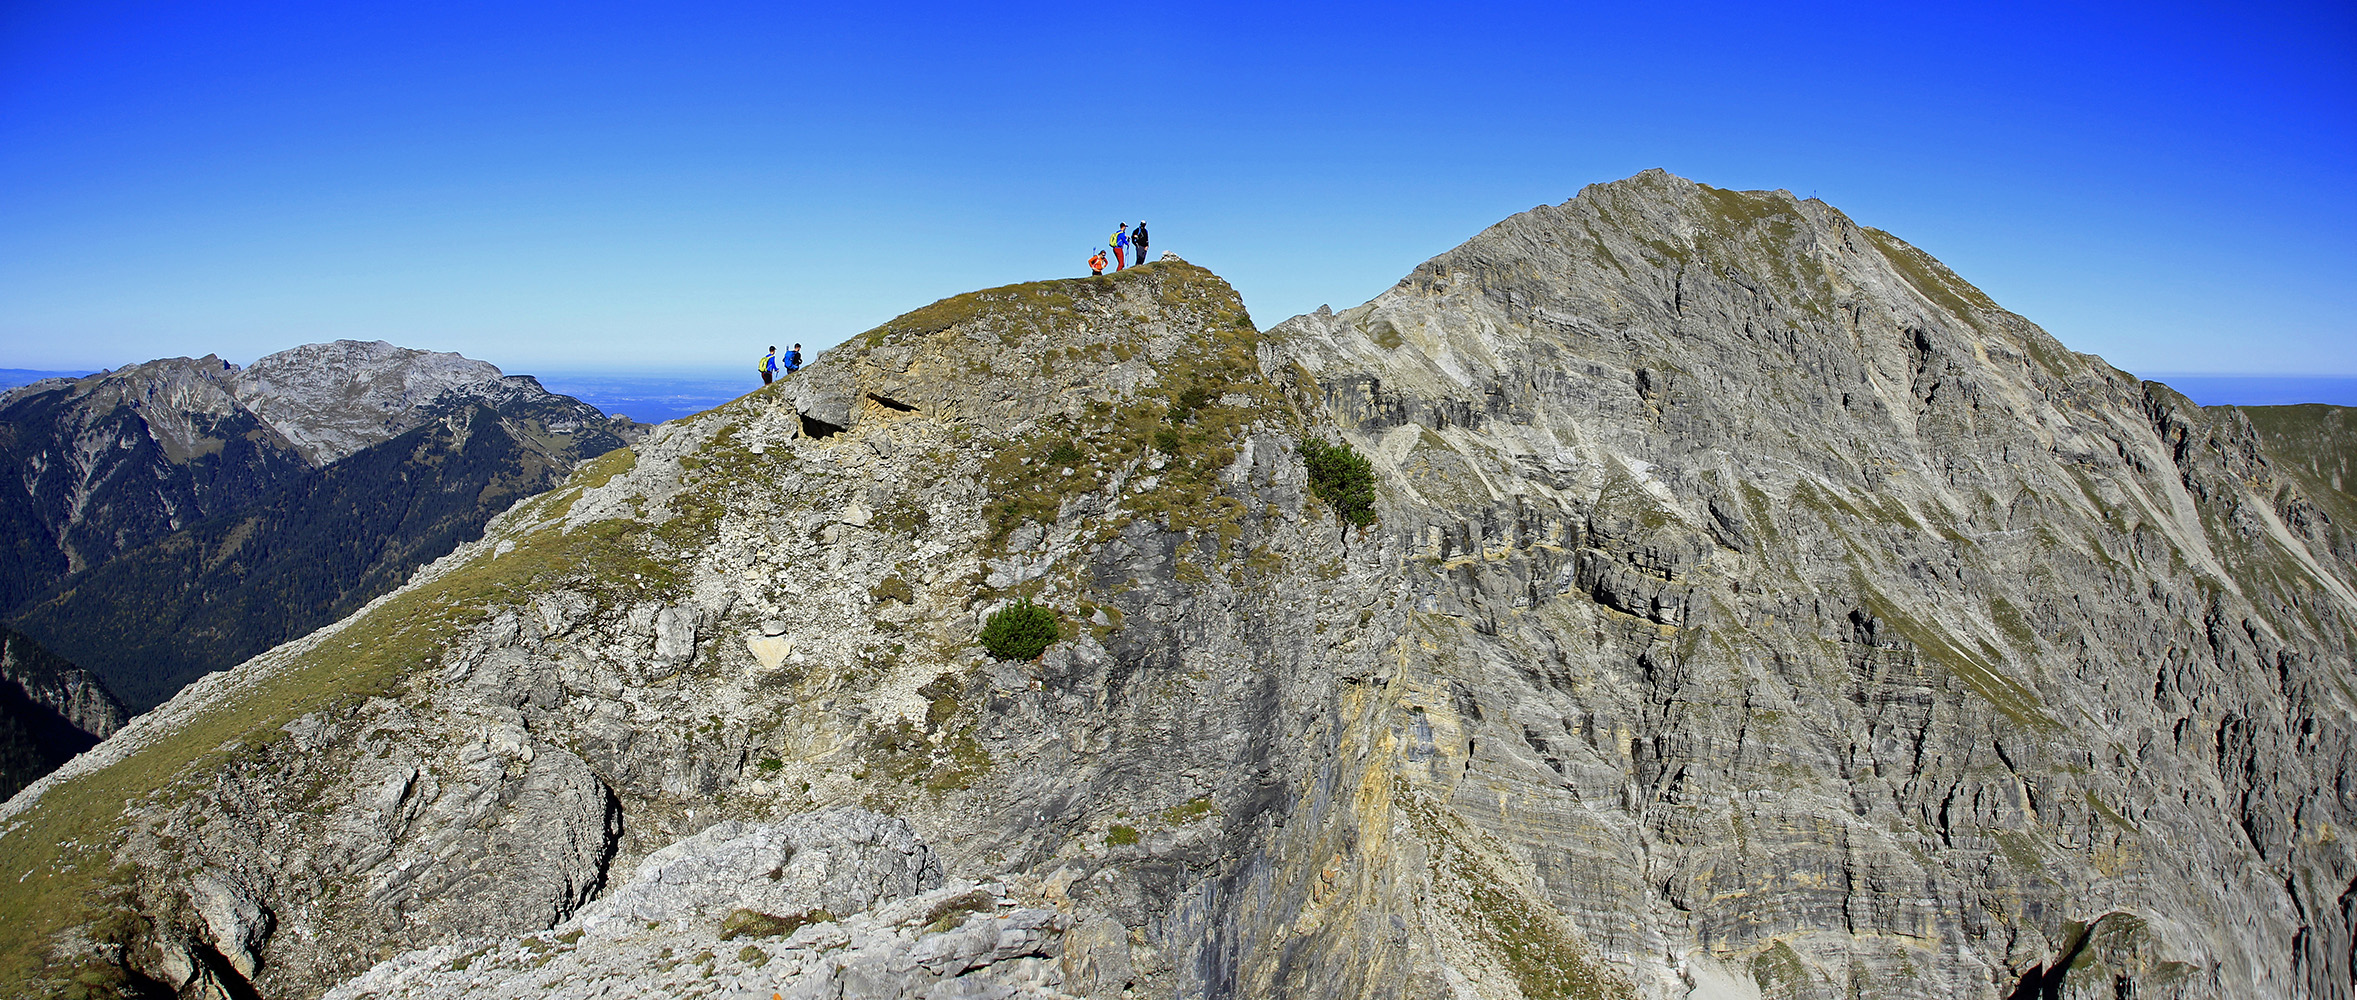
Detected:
[{"left": 0, "top": 0, "right": 2357, "bottom": 375}]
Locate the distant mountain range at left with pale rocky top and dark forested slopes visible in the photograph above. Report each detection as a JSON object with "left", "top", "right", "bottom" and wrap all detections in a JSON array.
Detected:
[{"left": 0, "top": 340, "right": 646, "bottom": 726}]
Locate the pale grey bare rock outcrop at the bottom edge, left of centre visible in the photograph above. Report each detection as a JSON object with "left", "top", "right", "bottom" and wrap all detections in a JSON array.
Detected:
[{"left": 328, "top": 809, "right": 1070, "bottom": 1000}]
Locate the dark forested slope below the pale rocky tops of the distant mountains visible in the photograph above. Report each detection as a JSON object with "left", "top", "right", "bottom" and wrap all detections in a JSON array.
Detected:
[{"left": 14, "top": 403, "right": 645, "bottom": 710}]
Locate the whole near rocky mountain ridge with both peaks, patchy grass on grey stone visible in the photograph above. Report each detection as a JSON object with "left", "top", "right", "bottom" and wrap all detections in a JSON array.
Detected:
[{"left": 0, "top": 172, "right": 2357, "bottom": 998}]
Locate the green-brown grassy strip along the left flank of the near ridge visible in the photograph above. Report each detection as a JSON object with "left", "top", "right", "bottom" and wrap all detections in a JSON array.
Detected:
[{"left": 0, "top": 448, "right": 643, "bottom": 995}]
